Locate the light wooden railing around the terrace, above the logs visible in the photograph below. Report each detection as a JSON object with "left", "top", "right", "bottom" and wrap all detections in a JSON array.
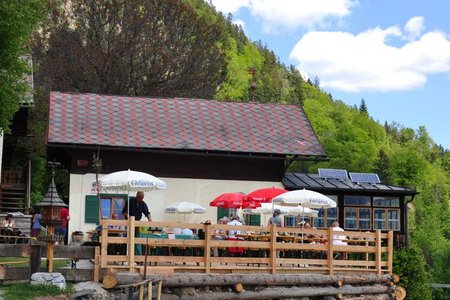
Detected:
[{"left": 100, "top": 218, "right": 393, "bottom": 275}]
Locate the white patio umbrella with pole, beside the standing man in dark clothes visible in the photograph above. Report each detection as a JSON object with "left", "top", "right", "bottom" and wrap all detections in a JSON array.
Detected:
[{"left": 98, "top": 169, "right": 166, "bottom": 213}]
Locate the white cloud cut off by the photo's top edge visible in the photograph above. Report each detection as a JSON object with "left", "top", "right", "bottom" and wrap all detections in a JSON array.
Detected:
[{"left": 212, "top": 0, "right": 357, "bottom": 32}]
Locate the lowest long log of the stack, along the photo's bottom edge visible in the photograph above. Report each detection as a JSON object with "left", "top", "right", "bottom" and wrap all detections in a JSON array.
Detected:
[{"left": 158, "top": 285, "right": 392, "bottom": 300}]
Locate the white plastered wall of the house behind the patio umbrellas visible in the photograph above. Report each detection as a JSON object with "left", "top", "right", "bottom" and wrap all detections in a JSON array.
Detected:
[{"left": 68, "top": 174, "right": 283, "bottom": 234}]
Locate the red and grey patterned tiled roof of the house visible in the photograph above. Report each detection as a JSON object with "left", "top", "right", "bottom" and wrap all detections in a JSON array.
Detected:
[{"left": 48, "top": 92, "right": 325, "bottom": 156}]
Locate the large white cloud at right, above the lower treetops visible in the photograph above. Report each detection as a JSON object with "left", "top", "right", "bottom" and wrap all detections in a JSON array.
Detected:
[{"left": 290, "top": 17, "right": 450, "bottom": 92}]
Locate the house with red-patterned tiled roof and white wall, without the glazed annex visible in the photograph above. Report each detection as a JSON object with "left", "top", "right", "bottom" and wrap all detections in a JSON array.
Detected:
[{"left": 47, "top": 92, "right": 326, "bottom": 232}]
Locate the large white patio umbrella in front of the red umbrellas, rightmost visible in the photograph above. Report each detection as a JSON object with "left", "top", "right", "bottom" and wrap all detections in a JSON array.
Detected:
[{"left": 272, "top": 189, "right": 336, "bottom": 208}]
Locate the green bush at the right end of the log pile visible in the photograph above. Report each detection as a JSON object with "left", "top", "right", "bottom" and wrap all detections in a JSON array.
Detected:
[{"left": 393, "top": 246, "right": 432, "bottom": 300}]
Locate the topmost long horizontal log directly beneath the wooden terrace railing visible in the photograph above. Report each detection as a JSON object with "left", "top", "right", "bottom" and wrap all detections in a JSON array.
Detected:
[{"left": 147, "top": 273, "right": 391, "bottom": 287}]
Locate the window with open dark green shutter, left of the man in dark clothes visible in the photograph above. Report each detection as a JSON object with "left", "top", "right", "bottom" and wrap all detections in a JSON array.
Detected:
[{"left": 84, "top": 195, "right": 126, "bottom": 224}]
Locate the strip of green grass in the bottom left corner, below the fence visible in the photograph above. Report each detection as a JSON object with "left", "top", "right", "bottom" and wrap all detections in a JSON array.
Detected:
[{"left": 0, "top": 283, "right": 74, "bottom": 300}]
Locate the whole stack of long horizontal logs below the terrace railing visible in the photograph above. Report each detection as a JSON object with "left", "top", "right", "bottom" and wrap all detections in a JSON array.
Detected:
[{"left": 147, "top": 273, "right": 404, "bottom": 300}]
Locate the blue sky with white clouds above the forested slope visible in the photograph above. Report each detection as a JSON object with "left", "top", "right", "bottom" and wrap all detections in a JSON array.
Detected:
[{"left": 211, "top": 0, "right": 450, "bottom": 149}]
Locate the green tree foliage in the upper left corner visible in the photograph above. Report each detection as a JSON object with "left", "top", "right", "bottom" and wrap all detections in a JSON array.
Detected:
[{"left": 0, "top": 0, "right": 44, "bottom": 132}]
